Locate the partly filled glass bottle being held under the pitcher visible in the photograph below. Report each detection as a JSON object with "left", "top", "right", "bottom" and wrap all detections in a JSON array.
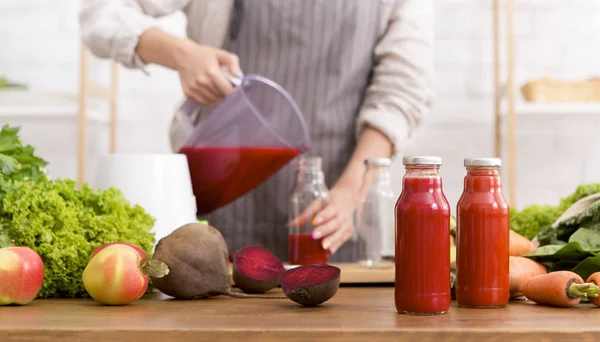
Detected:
[{"left": 288, "top": 156, "right": 329, "bottom": 265}]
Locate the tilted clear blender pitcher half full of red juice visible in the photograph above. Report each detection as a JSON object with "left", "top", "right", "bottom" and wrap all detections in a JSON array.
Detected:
[{"left": 177, "top": 71, "right": 310, "bottom": 215}]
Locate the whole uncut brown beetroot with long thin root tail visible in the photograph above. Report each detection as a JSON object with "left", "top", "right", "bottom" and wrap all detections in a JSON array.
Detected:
[{"left": 152, "top": 223, "right": 285, "bottom": 299}]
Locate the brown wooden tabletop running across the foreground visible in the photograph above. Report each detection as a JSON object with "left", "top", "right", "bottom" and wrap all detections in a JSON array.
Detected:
[{"left": 0, "top": 287, "right": 600, "bottom": 342}]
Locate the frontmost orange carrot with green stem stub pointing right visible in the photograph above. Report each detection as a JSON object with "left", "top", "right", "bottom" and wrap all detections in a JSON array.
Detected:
[{"left": 520, "top": 271, "right": 600, "bottom": 308}]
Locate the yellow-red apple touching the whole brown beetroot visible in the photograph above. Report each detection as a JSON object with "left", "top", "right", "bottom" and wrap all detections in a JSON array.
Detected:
[{"left": 83, "top": 243, "right": 148, "bottom": 305}]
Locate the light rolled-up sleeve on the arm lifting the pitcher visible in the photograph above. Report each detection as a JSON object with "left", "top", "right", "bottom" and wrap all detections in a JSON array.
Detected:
[{"left": 79, "top": 0, "right": 189, "bottom": 68}]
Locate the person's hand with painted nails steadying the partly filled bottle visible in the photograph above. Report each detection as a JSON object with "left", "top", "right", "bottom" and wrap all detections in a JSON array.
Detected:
[{"left": 312, "top": 184, "right": 358, "bottom": 254}]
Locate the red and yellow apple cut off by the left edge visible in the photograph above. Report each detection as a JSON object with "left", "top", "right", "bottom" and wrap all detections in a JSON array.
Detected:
[{"left": 0, "top": 241, "right": 44, "bottom": 305}]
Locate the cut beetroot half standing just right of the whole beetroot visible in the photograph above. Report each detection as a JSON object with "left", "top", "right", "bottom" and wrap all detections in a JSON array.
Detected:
[{"left": 233, "top": 246, "right": 285, "bottom": 293}]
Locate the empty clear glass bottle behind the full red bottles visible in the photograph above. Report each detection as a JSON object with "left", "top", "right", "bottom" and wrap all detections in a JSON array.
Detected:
[{"left": 357, "top": 158, "right": 397, "bottom": 268}]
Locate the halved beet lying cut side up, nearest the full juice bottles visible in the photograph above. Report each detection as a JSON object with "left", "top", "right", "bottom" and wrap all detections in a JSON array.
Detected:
[{"left": 279, "top": 263, "right": 341, "bottom": 306}]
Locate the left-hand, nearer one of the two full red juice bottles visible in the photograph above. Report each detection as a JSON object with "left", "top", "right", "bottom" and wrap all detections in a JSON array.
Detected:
[{"left": 394, "top": 156, "right": 451, "bottom": 315}]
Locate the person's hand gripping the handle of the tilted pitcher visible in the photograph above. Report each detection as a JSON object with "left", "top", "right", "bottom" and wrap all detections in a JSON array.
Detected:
[{"left": 175, "top": 40, "right": 242, "bottom": 105}]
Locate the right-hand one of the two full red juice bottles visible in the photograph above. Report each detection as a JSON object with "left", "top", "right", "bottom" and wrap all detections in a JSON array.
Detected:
[{"left": 456, "top": 158, "right": 510, "bottom": 308}]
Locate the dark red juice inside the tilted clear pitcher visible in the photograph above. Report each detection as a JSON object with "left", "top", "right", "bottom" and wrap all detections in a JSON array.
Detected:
[{"left": 179, "top": 147, "right": 300, "bottom": 215}]
